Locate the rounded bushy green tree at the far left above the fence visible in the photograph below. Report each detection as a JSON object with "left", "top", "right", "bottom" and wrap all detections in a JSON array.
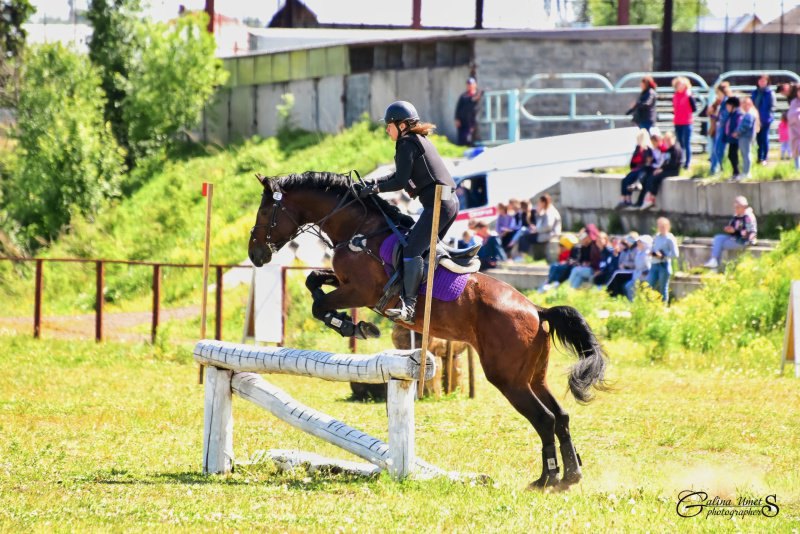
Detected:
[{"left": 3, "top": 44, "right": 124, "bottom": 248}]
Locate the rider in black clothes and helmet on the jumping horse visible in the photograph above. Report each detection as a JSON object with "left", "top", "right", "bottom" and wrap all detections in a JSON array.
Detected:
[{"left": 359, "top": 100, "right": 458, "bottom": 324}]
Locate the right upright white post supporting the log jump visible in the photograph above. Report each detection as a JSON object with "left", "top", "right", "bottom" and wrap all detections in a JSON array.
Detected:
[{"left": 386, "top": 379, "right": 417, "bottom": 478}]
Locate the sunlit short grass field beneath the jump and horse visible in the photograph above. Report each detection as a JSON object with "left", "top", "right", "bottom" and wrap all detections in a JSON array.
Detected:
[{"left": 0, "top": 335, "right": 800, "bottom": 532}]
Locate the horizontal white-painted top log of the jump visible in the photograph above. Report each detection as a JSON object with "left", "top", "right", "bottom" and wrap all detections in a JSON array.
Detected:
[{"left": 194, "top": 340, "right": 436, "bottom": 384}]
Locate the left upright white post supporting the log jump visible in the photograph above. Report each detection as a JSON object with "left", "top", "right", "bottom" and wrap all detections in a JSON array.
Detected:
[{"left": 203, "top": 367, "right": 233, "bottom": 474}]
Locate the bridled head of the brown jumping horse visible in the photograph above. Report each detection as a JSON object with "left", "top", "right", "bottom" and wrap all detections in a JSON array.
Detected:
[{"left": 247, "top": 175, "right": 299, "bottom": 267}]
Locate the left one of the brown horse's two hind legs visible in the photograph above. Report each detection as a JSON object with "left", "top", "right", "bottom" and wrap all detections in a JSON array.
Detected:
[{"left": 490, "top": 384, "right": 559, "bottom": 488}]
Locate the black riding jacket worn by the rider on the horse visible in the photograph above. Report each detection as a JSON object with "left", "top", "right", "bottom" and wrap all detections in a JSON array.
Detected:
[{"left": 376, "top": 133, "right": 456, "bottom": 208}]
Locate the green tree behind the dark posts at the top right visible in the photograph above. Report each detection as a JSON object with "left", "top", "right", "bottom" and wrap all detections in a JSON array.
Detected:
[{"left": 585, "top": 0, "right": 709, "bottom": 31}]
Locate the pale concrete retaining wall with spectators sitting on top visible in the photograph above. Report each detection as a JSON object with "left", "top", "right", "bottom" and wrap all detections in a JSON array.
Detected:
[{"left": 558, "top": 174, "right": 800, "bottom": 235}]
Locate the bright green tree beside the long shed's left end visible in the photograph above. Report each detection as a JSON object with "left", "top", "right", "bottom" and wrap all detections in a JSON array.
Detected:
[{"left": 119, "top": 13, "right": 227, "bottom": 158}]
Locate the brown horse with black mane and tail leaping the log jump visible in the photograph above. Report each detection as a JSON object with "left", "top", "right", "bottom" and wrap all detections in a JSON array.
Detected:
[{"left": 248, "top": 171, "right": 608, "bottom": 489}]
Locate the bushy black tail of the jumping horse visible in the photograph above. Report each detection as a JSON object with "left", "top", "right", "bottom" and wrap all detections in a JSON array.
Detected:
[{"left": 538, "top": 306, "right": 610, "bottom": 403}]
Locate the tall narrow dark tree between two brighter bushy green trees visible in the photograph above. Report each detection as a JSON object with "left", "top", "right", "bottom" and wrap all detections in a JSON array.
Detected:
[{"left": 86, "top": 0, "right": 141, "bottom": 163}]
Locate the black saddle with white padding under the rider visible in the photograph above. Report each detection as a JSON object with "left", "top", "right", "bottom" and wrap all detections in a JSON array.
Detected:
[{"left": 374, "top": 237, "right": 481, "bottom": 313}]
